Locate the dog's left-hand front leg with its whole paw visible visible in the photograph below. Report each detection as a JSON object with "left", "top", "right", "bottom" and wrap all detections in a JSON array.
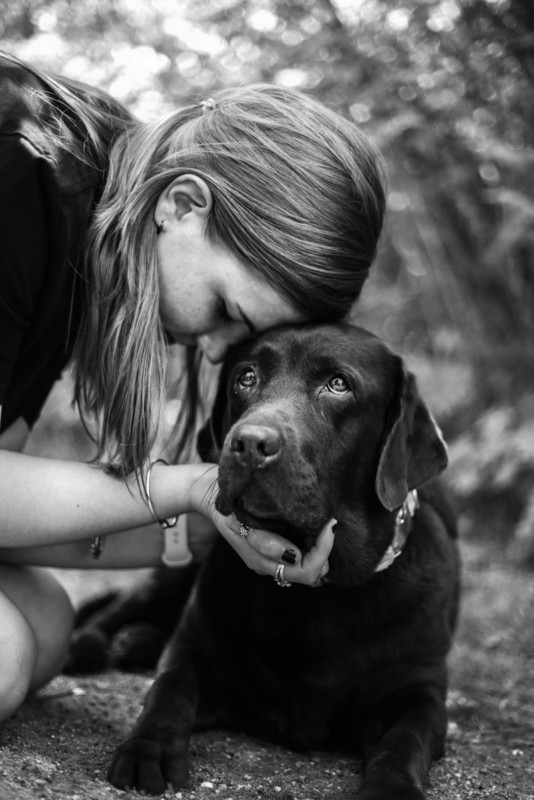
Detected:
[{"left": 108, "top": 648, "right": 198, "bottom": 794}]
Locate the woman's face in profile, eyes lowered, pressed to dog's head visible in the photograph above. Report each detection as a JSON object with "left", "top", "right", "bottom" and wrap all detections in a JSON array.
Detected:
[{"left": 157, "top": 214, "right": 306, "bottom": 364}]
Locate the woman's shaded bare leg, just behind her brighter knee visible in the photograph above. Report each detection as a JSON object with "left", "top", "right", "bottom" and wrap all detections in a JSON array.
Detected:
[{"left": 0, "top": 564, "right": 74, "bottom": 689}]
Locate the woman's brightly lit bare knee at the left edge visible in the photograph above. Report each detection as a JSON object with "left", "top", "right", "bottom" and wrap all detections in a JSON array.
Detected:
[{"left": 0, "top": 592, "right": 37, "bottom": 722}]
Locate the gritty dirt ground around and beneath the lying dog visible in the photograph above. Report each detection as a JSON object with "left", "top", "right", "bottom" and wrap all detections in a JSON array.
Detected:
[{"left": 0, "top": 544, "right": 534, "bottom": 800}]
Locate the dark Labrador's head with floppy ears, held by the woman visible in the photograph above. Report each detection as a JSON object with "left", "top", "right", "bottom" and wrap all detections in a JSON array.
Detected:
[{"left": 199, "top": 324, "right": 447, "bottom": 585}]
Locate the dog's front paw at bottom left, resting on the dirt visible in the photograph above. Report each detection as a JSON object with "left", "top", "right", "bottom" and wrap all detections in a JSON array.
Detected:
[{"left": 108, "top": 737, "right": 188, "bottom": 794}]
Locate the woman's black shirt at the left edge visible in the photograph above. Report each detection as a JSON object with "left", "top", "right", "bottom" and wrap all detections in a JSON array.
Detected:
[{"left": 0, "top": 56, "right": 104, "bottom": 430}]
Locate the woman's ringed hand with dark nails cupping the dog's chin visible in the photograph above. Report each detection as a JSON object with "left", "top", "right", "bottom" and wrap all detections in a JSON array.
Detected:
[{"left": 190, "top": 465, "right": 335, "bottom": 586}]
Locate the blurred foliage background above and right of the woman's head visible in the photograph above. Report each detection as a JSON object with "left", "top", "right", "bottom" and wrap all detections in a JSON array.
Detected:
[{"left": 4, "top": 0, "right": 534, "bottom": 552}]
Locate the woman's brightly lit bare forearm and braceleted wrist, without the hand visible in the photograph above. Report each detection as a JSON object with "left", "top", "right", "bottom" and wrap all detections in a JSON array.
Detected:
[{"left": 0, "top": 451, "right": 216, "bottom": 547}]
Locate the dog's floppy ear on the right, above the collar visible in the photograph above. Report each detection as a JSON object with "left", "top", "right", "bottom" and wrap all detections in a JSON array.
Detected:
[{"left": 375, "top": 367, "right": 448, "bottom": 511}]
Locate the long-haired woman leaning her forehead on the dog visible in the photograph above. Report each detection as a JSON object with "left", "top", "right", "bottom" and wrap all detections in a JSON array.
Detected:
[{"left": 0, "top": 56, "right": 384, "bottom": 719}]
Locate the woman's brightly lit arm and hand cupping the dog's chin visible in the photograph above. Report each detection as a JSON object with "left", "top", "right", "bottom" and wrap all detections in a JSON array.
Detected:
[{"left": 0, "top": 451, "right": 333, "bottom": 585}]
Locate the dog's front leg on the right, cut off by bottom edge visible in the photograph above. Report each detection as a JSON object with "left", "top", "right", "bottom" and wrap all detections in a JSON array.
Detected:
[{"left": 357, "top": 686, "right": 447, "bottom": 800}]
